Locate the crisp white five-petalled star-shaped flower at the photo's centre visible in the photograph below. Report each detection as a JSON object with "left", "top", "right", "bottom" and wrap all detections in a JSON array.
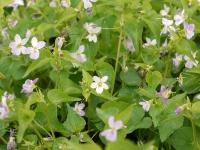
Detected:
[{"left": 90, "top": 76, "right": 109, "bottom": 94}]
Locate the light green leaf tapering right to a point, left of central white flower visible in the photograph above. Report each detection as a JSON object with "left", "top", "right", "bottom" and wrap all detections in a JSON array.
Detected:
[{"left": 47, "top": 89, "right": 81, "bottom": 105}]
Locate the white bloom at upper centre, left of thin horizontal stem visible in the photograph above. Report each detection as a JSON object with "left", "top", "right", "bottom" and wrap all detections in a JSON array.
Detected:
[{"left": 84, "top": 22, "right": 101, "bottom": 43}]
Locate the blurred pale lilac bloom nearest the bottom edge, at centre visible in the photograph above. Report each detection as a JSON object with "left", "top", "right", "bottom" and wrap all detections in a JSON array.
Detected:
[{"left": 100, "top": 116, "right": 124, "bottom": 142}]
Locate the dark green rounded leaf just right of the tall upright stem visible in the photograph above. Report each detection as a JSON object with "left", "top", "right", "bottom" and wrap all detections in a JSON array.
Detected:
[{"left": 120, "top": 68, "right": 142, "bottom": 86}]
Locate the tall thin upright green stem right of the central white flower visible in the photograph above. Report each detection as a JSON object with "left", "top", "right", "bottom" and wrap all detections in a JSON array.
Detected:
[{"left": 111, "top": 15, "right": 123, "bottom": 94}]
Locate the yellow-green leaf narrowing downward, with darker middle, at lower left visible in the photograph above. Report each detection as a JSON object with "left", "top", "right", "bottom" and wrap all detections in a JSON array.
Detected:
[{"left": 17, "top": 108, "right": 35, "bottom": 143}]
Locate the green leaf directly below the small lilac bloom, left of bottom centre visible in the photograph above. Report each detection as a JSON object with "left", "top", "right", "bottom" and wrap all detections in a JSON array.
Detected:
[{"left": 63, "top": 105, "right": 86, "bottom": 133}]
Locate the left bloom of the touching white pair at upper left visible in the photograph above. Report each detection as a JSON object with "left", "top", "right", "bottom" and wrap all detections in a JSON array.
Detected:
[{"left": 9, "top": 34, "right": 28, "bottom": 56}]
